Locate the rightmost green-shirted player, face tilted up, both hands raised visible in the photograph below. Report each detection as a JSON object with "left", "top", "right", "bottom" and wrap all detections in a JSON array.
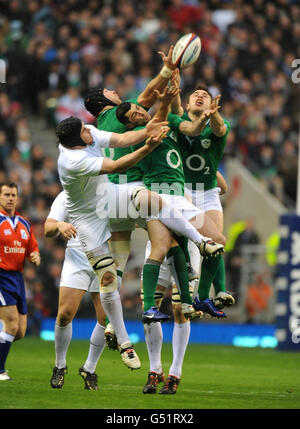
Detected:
[{"left": 168, "top": 83, "right": 235, "bottom": 311}]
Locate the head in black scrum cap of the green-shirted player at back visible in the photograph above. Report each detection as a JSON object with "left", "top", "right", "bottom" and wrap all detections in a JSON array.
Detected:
[{"left": 84, "top": 87, "right": 122, "bottom": 118}]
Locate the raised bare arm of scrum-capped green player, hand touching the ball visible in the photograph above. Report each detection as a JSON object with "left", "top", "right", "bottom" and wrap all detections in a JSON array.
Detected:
[{"left": 138, "top": 46, "right": 176, "bottom": 107}]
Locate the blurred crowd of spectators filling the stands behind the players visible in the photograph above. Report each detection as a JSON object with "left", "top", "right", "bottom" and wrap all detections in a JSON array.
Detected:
[{"left": 0, "top": 0, "right": 300, "bottom": 317}]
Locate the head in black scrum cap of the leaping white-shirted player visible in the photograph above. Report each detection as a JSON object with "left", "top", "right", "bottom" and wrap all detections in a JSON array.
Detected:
[{"left": 56, "top": 116, "right": 93, "bottom": 148}]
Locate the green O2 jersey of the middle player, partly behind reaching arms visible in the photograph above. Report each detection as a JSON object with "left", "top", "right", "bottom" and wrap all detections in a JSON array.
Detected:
[{"left": 131, "top": 127, "right": 184, "bottom": 196}]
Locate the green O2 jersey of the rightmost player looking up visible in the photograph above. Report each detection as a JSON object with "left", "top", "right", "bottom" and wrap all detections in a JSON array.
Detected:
[{"left": 168, "top": 113, "right": 230, "bottom": 191}]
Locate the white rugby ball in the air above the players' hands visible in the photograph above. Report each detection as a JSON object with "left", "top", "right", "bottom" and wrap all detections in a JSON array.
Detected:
[{"left": 172, "top": 33, "right": 201, "bottom": 69}]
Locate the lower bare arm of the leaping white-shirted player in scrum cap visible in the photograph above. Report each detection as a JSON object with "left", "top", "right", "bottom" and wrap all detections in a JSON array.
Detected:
[{"left": 100, "top": 127, "right": 169, "bottom": 174}]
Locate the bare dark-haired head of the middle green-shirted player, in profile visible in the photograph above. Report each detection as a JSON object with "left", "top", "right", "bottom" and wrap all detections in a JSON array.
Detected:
[{"left": 116, "top": 101, "right": 151, "bottom": 129}]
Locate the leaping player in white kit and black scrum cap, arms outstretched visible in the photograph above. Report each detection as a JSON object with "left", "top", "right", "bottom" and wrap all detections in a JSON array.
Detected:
[{"left": 56, "top": 117, "right": 168, "bottom": 369}]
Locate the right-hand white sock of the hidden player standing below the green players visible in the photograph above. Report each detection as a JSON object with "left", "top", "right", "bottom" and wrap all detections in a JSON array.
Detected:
[{"left": 169, "top": 322, "right": 191, "bottom": 378}]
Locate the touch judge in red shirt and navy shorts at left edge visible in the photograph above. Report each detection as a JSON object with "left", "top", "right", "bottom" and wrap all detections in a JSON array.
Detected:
[{"left": 0, "top": 182, "right": 41, "bottom": 381}]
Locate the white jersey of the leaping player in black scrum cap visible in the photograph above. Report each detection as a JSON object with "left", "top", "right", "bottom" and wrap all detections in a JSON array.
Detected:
[{"left": 57, "top": 125, "right": 112, "bottom": 219}]
